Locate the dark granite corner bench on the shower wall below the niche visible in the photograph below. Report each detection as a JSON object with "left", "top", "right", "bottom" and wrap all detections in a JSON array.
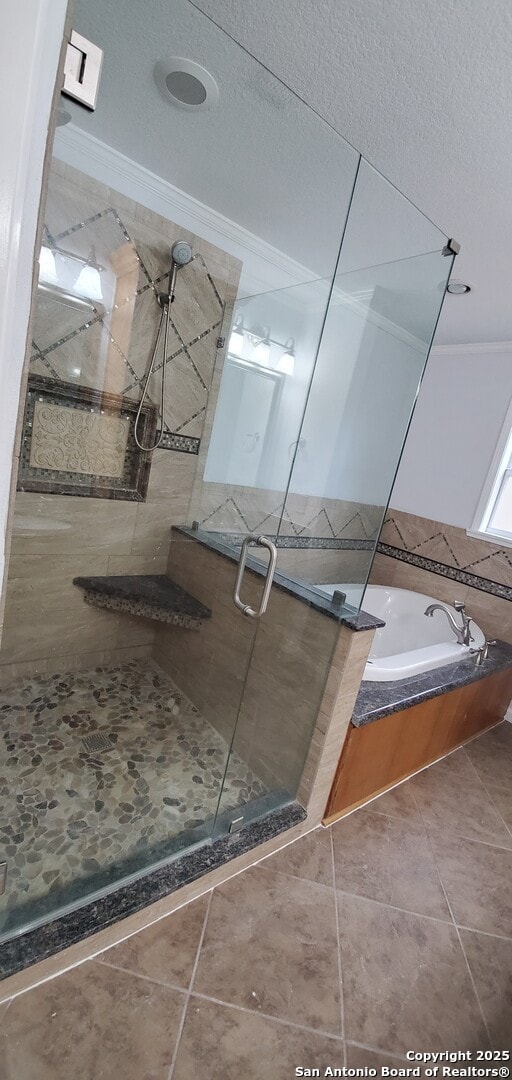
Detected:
[{"left": 73, "top": 573, "right": 212, "bottom": 630}]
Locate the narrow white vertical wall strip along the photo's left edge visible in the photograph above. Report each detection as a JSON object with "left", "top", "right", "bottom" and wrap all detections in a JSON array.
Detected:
[{"left": 0, "top": 0, "right": 67, "bottom": 596}]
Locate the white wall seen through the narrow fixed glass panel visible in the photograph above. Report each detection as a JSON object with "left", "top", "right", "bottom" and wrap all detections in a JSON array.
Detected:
[{"left": 291, "top": 288, "right": 427, "bottom": 505}]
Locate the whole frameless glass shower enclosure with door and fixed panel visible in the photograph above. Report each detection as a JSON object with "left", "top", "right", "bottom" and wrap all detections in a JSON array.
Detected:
[{"left": 0, "top": 0, "right": 454, "bottom": 940}]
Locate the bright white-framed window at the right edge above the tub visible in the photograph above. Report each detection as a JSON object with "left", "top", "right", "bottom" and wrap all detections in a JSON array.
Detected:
[{"left": 468, "top": 404, "right": 512, "bottom": 548}]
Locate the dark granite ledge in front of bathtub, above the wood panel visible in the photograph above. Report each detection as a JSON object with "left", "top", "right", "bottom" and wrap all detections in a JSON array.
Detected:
[{"left": 352, "top": 642, "right": 512, "bottom": 728}]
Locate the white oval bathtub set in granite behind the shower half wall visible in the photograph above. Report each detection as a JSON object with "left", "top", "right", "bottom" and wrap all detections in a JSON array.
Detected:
[{"left": 318, "top": 583, "right": 485, "bottom": 683}]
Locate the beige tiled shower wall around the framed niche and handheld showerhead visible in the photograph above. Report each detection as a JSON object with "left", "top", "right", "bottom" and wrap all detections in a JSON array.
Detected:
[{"left": 0, "top": 161, "right": 240, "bottom": 680}]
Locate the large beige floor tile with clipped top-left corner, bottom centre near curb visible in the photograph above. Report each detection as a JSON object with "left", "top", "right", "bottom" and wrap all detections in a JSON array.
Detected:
[{"left": 193, "top": 867, "right": 341, "bottom": 1035}]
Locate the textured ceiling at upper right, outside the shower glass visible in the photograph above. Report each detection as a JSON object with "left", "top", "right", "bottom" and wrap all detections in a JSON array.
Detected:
[{"left": 190, "top": 0, "right": 512, "bottom": 343}]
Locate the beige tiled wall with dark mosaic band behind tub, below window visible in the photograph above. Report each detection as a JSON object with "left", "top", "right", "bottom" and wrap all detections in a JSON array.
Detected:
[{"left": 370, "top": 509, "right": 512, "bottom": 642}]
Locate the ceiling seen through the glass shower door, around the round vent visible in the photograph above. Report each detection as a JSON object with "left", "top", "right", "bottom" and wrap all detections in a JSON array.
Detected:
[{"left": 57, "top": 0, "right": 359, "bottom": 296}]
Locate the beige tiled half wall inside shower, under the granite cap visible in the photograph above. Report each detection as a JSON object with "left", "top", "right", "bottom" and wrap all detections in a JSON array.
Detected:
[{"left": 154, "top": 532, "right": 339, "bottom": 793}]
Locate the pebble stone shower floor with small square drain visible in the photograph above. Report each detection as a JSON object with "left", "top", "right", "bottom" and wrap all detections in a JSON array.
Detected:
[{"left": 0, "top": 660, "right": 265, "bottom": 932}]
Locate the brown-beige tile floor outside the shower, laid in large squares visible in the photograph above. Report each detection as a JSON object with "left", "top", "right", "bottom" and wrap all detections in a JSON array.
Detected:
[{"left": 0, "top": 724, "right": 512, "bottom": 1080}]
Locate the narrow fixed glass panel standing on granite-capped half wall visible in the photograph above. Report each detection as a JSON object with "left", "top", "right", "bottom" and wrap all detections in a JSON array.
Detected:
[{"left": 274, "top": 161, "right": 453, "bottom": 611}]
